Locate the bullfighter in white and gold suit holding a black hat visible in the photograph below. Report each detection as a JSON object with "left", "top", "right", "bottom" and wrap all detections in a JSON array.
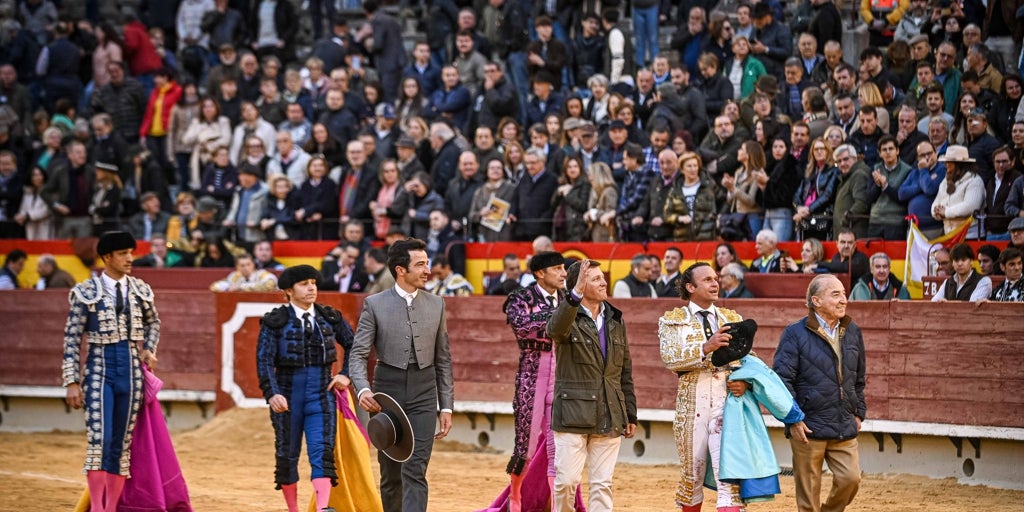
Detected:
[{"left": 657, "top": 262, "right": 748, "bottom": 512}]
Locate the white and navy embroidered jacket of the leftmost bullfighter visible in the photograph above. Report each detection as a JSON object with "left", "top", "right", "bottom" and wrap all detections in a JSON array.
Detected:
[{"left": 62, "top": 275, "right": 160, "bottom": 386}]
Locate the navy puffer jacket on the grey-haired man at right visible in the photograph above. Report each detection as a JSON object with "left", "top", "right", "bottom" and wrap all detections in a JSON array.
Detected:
[{"left": 772, "top": 312, "right": 867, "bottom": 440}]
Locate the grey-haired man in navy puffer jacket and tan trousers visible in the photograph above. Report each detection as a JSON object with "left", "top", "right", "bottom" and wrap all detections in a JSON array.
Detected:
[{"left": 772, "top": 274, "right": 867, "bottom": 512}]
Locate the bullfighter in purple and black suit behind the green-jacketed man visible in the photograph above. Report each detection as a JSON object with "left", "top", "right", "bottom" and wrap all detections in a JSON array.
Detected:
[{"left": 502, "top": 251, "right": 565, "bottom": 512}]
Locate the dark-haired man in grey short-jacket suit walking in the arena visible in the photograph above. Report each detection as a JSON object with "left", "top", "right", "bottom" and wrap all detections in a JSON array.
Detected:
[{"left": 350, "top": 239, "right": 455, "bottom": 512}]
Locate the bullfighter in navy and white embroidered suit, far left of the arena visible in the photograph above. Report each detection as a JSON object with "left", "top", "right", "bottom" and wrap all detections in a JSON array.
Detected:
[{"left": 62, "top": 231, "right": 160, "bottom": 512}]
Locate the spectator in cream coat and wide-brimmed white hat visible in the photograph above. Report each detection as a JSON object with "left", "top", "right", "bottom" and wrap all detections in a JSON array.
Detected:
[{"left": 932, "top": 145, "right": 985, "bottom": 240}]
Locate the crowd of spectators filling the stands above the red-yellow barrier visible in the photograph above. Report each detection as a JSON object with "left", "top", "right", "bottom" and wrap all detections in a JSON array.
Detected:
[{"left": 0, "top": 0, "right": 1024, "bottom": 272}]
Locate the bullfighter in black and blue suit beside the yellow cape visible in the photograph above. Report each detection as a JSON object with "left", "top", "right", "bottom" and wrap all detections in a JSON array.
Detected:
[{"left": 256, "top": 265, "right": 352, "bottom": 512}]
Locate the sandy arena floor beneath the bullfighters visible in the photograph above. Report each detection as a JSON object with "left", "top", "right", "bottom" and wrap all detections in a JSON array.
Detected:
[{"left": 0, "top": 410, "right": 1024, "bottom": 512}]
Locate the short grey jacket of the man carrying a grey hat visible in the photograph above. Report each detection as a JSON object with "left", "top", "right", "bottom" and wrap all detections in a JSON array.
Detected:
[{"left": 349, "top": 288, "right": 455, "bottom": 410}]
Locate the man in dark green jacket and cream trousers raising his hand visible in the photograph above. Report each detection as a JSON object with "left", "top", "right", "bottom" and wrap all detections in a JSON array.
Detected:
[{"left": 546, "top": 259, "right": 637, "bottom": 512}]
